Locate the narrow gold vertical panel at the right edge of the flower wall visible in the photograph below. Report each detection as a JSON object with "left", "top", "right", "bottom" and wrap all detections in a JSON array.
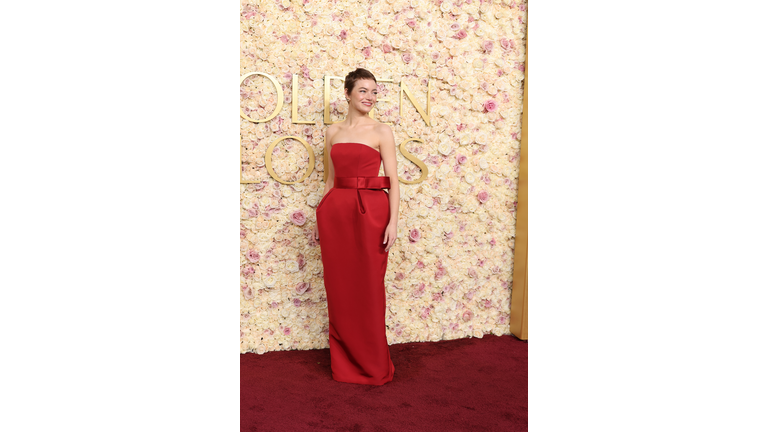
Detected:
[{"left": 509, "top": 22, "right": 530, "bottom": 340}]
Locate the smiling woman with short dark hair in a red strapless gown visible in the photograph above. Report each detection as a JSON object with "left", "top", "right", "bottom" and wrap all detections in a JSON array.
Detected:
[{"left": 315, "top": 68, "right": 400, "bottom": 385}]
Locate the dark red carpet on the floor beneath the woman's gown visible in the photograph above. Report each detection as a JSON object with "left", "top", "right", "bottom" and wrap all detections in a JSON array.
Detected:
[{"left": 240, "top": 335, "right": 528, "bottom": 432}]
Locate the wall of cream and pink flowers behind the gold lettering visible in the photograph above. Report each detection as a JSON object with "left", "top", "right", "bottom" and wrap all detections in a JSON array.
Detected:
[{"left": 240, "top": 0, "right": 526, "bottom": 354}]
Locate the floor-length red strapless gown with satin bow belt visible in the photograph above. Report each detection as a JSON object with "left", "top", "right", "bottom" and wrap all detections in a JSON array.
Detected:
[{"left": 316, "top": 143, "right": 395, "bottom": 385}]
